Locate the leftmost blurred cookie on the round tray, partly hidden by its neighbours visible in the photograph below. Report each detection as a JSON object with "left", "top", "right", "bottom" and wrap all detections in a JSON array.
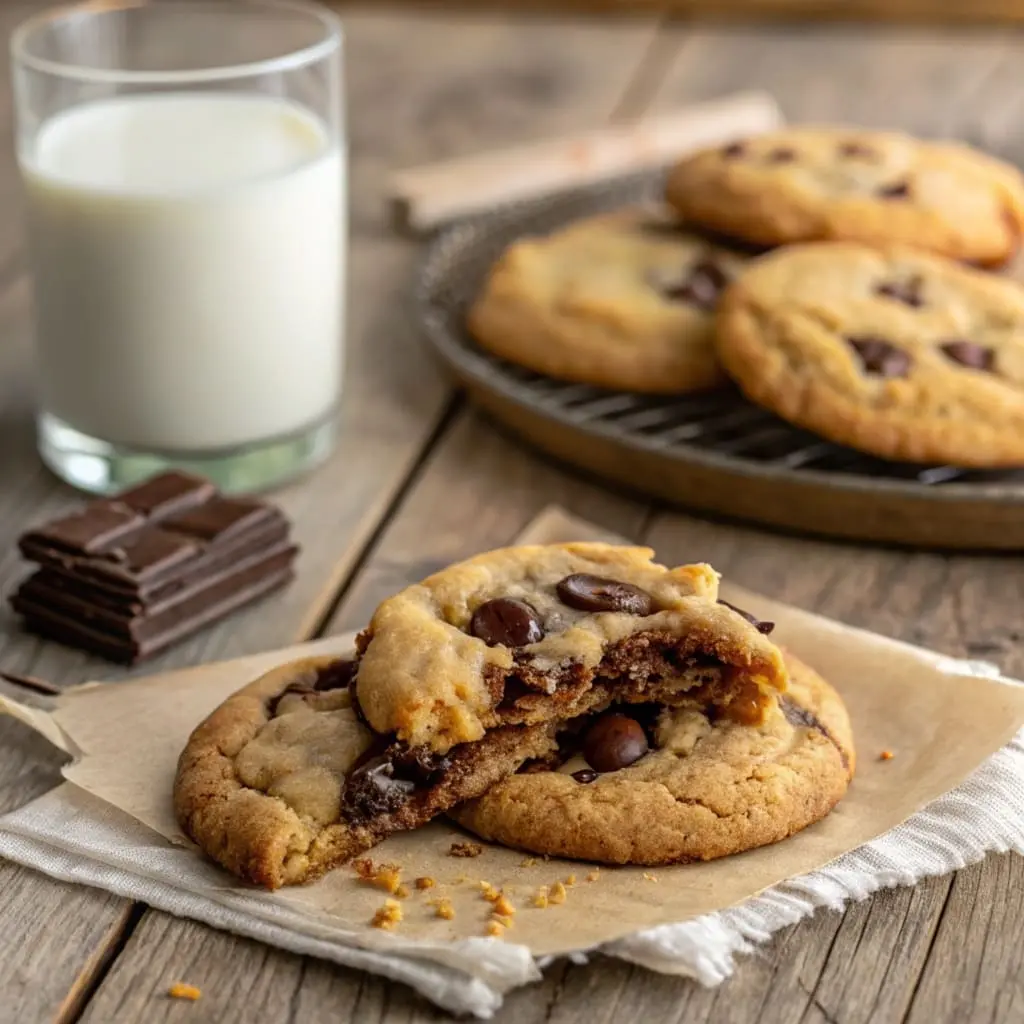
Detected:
[{"left": 468, "top": 208, "right": 744, "bottom": 393}]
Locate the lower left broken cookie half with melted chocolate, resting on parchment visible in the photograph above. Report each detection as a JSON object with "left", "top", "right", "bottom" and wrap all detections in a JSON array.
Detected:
[{"left": 174, "top": 657, "right": 554, "bottom": 889}]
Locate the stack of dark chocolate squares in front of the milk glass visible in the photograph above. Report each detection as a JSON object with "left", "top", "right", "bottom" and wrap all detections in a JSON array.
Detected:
[{"left": 11, "top": 472, "right": 298, "bottom": 665}]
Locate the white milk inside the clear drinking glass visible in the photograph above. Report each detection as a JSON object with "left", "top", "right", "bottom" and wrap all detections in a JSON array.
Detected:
[{"left": 20, "top": 93, "right": 345, "bottom": 453}]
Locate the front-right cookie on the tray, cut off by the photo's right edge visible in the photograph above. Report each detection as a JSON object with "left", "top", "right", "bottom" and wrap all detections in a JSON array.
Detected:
[{"left": 717, "top": 243, "right": 1024, "bottom": 467}]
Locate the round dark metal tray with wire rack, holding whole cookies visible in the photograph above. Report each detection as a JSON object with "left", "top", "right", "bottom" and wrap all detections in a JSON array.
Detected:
[{"left": 416, "top": 174, "right": 1024, "bottom": 550}]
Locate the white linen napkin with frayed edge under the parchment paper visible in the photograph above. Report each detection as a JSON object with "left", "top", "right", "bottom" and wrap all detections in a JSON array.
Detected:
[{"left": 0, "top": 655, "right": 1024, "bottom": 1018}]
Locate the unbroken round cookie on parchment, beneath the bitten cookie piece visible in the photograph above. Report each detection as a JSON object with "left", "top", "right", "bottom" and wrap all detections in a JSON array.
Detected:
[{"left": 451, "top": 655, "right": 855, "bottom": 864}]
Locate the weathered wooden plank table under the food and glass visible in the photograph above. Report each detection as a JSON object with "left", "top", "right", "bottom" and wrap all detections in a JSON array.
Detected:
[{"left": 0, "top": 3, "right": 1024, "bottom": 1024}]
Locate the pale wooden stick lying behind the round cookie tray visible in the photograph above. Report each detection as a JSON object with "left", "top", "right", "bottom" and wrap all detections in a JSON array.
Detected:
[{"left": 390, "top": 92, "right": 782, "bottom": 231}]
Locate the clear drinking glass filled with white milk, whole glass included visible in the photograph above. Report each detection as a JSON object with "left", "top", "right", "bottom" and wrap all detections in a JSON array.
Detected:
[{"left": 11, "top": 0, "right": 346, "bottom": 494}]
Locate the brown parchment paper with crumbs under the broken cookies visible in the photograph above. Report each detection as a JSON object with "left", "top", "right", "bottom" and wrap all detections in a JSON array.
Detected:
[{"left": 4, "top": 509, "right": 1024, "bottom": 959}]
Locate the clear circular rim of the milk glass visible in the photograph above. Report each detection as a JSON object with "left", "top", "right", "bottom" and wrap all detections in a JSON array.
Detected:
[{"left": 10, "top": 0, "right": 343, "bottom": 85}]
